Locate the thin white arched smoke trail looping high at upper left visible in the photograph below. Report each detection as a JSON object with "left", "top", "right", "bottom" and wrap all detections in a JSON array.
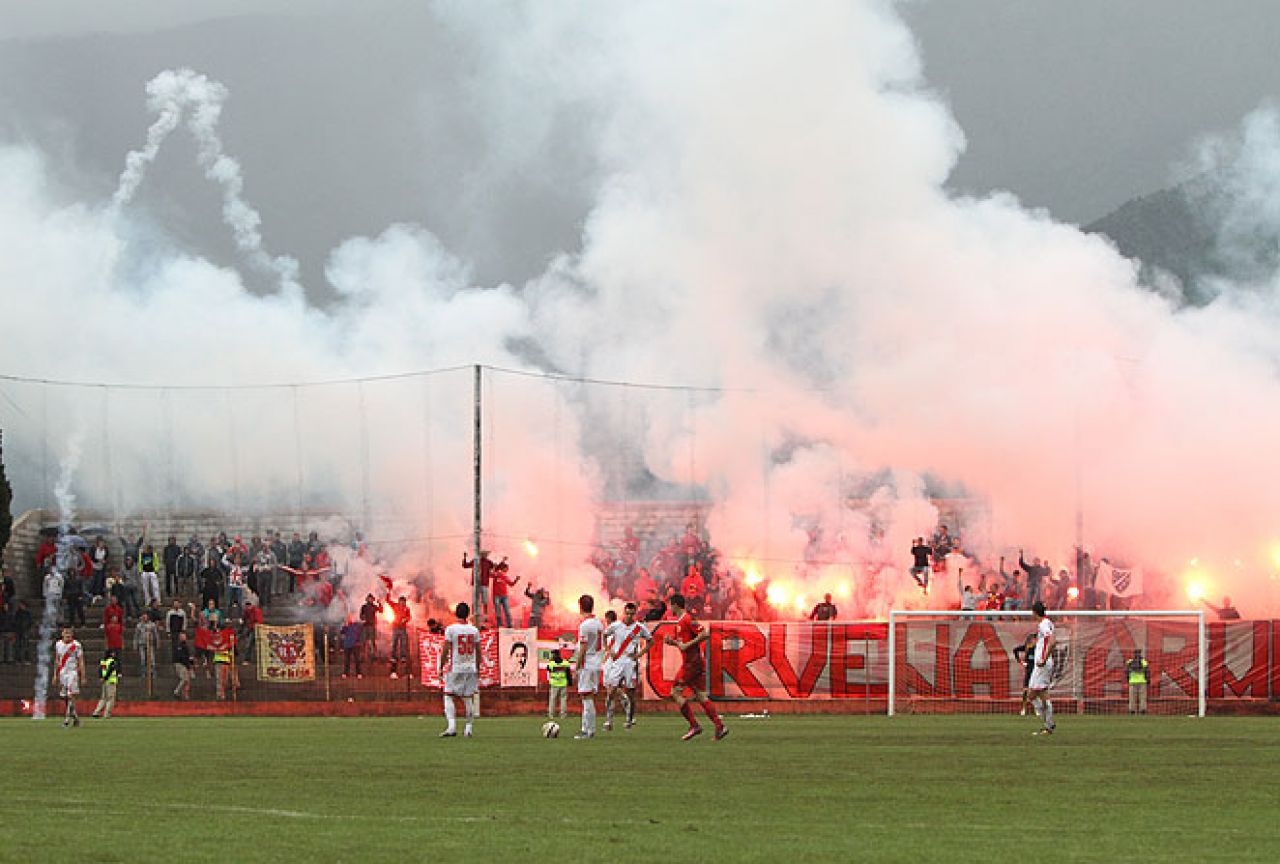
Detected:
[{"left": 111, "top": 69, "right": 298, "bottom": 291}]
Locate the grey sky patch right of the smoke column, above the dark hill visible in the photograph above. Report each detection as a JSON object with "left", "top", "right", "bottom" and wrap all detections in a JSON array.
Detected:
[{"left": 906, "top": 0, "right": 1280, "bottom": 223}]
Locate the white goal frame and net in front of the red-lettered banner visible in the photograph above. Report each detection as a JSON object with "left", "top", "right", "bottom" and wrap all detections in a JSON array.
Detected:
[{"left": 888, "top": 609, "right": 1208, "bottom": 717}]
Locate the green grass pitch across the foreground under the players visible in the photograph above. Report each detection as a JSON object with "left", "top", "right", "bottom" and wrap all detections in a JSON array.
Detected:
[{"left": 0, "top": 716, "right": 1280, "bottom": 864}]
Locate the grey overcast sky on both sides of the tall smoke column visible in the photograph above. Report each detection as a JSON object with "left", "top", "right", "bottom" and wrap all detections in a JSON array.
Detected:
[{"left": 0, "top": 0, "right": 1280, "bottom": 282}]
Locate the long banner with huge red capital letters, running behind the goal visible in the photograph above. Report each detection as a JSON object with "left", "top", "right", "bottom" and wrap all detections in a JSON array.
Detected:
[{"left": 624, "top": 617, "right": 1280, "bottom": 700}]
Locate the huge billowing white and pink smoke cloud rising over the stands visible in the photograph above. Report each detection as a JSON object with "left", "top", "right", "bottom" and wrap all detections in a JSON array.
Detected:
[{"left": 0, "top": 0, "right": 1280, "bottom": 616}]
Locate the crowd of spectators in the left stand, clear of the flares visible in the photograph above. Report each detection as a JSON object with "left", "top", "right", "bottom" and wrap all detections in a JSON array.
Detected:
[{"left": 11, "top": 525, "right": 430, "bottom": 698}]
